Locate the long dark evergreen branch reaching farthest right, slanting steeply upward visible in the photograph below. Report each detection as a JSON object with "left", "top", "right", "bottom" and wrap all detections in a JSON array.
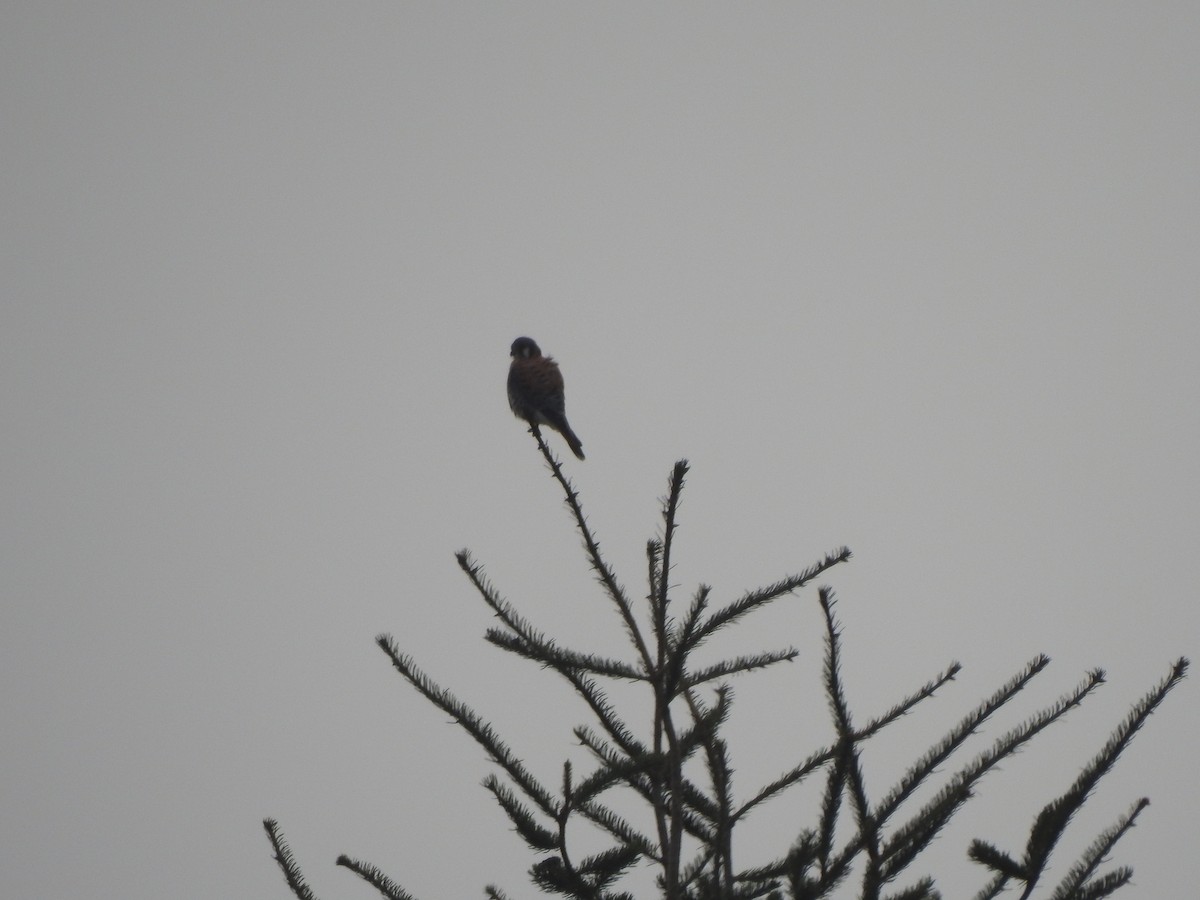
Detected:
[{"left": 1025, "top": 659, "right": 1188, "bottom": 896}]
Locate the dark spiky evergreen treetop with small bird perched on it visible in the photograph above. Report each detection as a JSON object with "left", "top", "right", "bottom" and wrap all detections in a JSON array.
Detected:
[{"left": 264, "top": 426, "right": 1188, "bottom": 900}]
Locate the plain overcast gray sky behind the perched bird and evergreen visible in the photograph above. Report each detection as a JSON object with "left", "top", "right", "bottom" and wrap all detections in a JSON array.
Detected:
[{"left": 0, "top": 7, "right": 1200, "bottom": 900}]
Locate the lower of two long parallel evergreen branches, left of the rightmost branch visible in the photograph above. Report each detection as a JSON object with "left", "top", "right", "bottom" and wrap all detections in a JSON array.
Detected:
[{"left": 883, "top": 659, "right": 1103, "bottom": 876}]
